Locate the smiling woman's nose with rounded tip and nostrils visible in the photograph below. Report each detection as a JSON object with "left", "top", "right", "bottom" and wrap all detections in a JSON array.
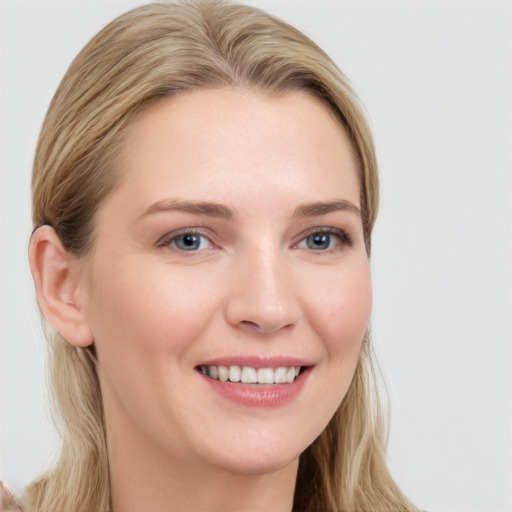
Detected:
[{"left": 226, "top": 248, "right": 301, "bottom": 335}]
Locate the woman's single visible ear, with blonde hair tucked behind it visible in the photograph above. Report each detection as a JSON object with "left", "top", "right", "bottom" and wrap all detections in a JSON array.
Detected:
[{"left": 29, "top": 226, "right": 94, "bottom": 347}]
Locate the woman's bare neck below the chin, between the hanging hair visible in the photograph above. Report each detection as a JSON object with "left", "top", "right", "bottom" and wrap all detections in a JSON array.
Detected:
[{"left": 110, "top": 414, "right": 298, "bottom": 512}]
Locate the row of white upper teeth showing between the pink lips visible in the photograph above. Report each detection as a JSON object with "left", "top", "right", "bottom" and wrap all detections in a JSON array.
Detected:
[{"left": 197, "top": 365, "right": 304, "bottom": 384}]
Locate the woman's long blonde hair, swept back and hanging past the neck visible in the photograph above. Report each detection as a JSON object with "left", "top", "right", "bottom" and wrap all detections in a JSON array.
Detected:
[{"left": 26, "top": 1, "right": 416, "bottom": 512}]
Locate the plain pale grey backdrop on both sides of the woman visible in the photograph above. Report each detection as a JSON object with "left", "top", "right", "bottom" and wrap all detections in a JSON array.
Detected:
[{"left": 0, "top": 0, "right": 512, "bottom": 512}]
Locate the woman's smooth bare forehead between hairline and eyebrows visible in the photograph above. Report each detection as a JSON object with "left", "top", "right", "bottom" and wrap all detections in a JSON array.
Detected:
[{"left": 112, "top": 88, "right": 359, "bottom": 214}]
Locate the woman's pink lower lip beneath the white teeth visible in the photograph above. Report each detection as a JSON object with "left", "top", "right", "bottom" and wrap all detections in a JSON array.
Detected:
[{"left": 200, "top": 368, "right": 311, "bottom": 407}]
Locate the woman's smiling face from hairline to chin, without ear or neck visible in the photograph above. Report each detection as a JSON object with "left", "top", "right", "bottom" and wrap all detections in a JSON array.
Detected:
[{"left": 80, "top": 89, "right": 371, "bottom": 474}]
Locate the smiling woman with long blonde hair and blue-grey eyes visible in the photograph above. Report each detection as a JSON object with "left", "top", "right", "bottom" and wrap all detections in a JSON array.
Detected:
[{"left": 26, "top": 2, "right": 415, "bottom": 512}]
